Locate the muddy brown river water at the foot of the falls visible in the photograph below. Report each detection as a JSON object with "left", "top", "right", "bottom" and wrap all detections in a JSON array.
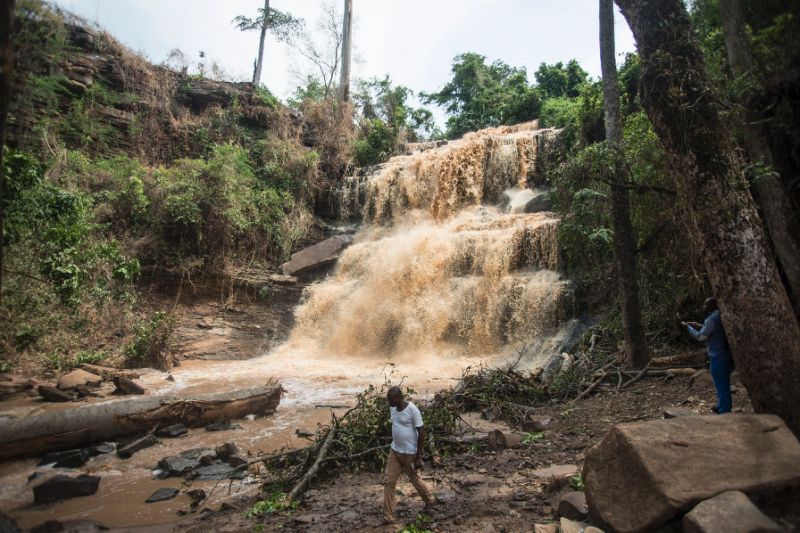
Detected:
[{"left": 0, "top": 341, "right": 502, "bottom": 531}]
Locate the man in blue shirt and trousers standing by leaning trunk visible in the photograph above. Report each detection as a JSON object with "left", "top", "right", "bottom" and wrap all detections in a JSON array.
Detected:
[{"left": 681, "top": 298, "right": 733, "bottom": 414}]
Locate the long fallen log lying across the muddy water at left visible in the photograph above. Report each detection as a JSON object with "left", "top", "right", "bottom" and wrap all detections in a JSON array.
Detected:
[{"left": 0, "top": 382, "right": 283, "bottom": 461}]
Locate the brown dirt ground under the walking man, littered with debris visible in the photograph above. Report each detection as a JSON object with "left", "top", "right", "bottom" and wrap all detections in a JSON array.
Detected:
[{"left": 174, "top": 368, "right": 752, "bottom": 533}]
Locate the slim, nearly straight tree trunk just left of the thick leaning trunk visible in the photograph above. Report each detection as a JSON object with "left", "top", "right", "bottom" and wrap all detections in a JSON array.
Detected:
[{"left": 600, "top": 0, "right": 650, "bottom": 369}]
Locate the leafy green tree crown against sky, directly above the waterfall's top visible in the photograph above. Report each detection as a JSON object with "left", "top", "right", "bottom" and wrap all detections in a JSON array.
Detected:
[{"left": 421, "top": 53, "right": 541, "bottom": 138}]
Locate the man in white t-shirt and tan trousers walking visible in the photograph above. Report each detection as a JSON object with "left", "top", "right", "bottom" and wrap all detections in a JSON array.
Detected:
[{"left": 383, "top": 387, "right": 436, "bottom": 523}]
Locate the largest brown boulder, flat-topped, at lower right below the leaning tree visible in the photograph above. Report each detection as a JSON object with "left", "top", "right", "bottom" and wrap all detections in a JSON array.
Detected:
[{"left": 583, "top": 414, "right": 800, "bottom": 533}]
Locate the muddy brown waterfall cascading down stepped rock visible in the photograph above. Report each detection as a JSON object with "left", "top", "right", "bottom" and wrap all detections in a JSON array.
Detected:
[{"left": 292, "top": 123, "right": 572, "bottom": 358}]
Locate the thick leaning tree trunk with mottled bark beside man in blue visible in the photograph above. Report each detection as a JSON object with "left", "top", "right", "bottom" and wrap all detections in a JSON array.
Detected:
[{"left": 616, "top": 0, "right": 800, "bottom": 434}]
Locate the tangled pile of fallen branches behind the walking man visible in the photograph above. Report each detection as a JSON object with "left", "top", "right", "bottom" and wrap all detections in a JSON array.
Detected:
[{"left": 228, "top": 344, "right": 694, "bottom": 504}]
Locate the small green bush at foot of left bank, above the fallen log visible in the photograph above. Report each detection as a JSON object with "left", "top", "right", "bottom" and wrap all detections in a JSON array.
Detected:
[{"left": 123, "top": 311, "right": 175, "bottom": 369}]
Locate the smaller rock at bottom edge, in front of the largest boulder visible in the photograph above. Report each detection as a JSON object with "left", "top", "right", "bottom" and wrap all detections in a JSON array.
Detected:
[{"left": 683, "top": 490, "right": 783, "bottom": 533}]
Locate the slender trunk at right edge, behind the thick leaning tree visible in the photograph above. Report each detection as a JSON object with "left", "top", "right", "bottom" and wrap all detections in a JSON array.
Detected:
[{"left": 719, "top": 0, "right": 800, "bottom": 316}]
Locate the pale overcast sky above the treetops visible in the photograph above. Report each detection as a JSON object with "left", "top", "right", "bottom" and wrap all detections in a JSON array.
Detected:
[{"left": 51, "top": 0, "right": 635, "bottom": 119}]
